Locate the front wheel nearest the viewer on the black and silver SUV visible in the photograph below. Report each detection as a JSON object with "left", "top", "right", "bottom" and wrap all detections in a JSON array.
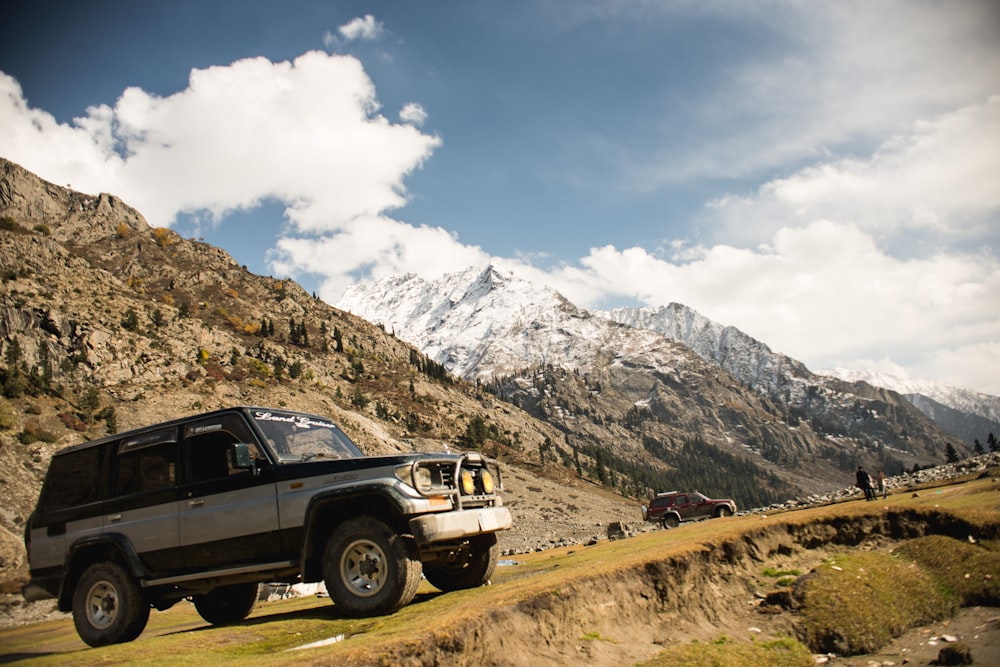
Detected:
[{"left": 323, "top": 516, "right": 420, "bottom": 616}]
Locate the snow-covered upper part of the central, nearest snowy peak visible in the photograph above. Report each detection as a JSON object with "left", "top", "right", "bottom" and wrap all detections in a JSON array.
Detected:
[{"left": 336, "top": 266, "right": 688, "bottom": 379}]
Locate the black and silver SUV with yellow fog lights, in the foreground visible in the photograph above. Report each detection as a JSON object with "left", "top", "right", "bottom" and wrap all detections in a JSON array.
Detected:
[{"left": 23, "top": 407, "right": 511, "bottom": 646}]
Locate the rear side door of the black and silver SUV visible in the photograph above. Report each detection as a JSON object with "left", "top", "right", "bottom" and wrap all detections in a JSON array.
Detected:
[{"left": 102, "top": 428, "right": 182, "bottom": 575}]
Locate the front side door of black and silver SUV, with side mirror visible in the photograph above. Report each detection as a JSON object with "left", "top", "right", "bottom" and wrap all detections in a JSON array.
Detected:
[{"left": 179, "top": 413, "right": 281, "bottom": 569}]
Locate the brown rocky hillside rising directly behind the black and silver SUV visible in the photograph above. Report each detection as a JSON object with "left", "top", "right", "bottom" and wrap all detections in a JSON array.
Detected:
[{"left": 0, "top": 160, "right": 638, "bottom": 593}]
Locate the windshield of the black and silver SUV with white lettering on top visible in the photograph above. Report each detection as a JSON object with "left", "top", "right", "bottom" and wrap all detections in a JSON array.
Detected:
[{"left": 250, "top": 410, "right": 364, "bottom": 462}]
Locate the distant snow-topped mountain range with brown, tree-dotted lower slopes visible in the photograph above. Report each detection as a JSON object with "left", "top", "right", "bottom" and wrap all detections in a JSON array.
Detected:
[{"left": 337, "top": 267, "right": 960, "bottom": 504}]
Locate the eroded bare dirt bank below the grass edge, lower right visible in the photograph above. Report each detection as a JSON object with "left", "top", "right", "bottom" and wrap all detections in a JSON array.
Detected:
[{"left": 330, "top": 510, "right": 1000, "bottom": 666}]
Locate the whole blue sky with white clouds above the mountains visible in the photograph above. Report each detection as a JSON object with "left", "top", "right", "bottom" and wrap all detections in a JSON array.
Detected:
[{"left": 0, "top": 0, "right": 1000, "bottom": 394}]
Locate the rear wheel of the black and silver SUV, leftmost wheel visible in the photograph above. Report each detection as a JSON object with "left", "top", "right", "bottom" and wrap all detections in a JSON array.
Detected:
[{"left": 73, "top": 562, "right": 149, "bottom": 646}]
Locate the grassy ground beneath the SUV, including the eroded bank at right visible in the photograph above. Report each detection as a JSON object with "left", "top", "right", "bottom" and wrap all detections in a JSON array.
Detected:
[{"left": 0, "top": 478, "right": 1000, "bottom": 667}]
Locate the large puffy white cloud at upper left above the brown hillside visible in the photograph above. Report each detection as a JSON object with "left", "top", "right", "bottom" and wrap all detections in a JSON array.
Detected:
[{"left": 0, "top": 52, "right": 440, "bottom": 232}]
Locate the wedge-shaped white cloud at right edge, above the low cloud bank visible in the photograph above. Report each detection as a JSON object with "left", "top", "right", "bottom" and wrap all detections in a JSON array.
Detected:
[{"left": 711, "top": 96, "right": 1000, "bottom": 247}]
